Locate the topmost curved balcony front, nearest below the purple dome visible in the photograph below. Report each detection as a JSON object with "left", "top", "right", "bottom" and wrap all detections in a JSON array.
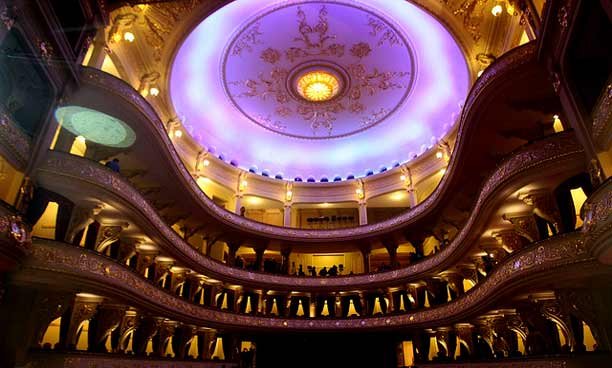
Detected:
[{"left": 75, "top": 43, "right": 536, "bottom": 243}]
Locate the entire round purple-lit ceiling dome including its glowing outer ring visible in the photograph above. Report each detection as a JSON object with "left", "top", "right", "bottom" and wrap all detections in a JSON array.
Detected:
[{"left": 170, "top": 0, "right": 469, "bottom": 179}]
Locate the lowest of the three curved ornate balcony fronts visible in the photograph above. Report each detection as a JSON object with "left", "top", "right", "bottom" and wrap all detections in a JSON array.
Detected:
[{"left": 13, "top": 232, "right": 596, "bottom": 331}]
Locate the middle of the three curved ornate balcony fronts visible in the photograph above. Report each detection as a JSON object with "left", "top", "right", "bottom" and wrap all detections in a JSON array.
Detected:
[{"left": 37, "top": 133, "right": 584, "bottom": 291}]
